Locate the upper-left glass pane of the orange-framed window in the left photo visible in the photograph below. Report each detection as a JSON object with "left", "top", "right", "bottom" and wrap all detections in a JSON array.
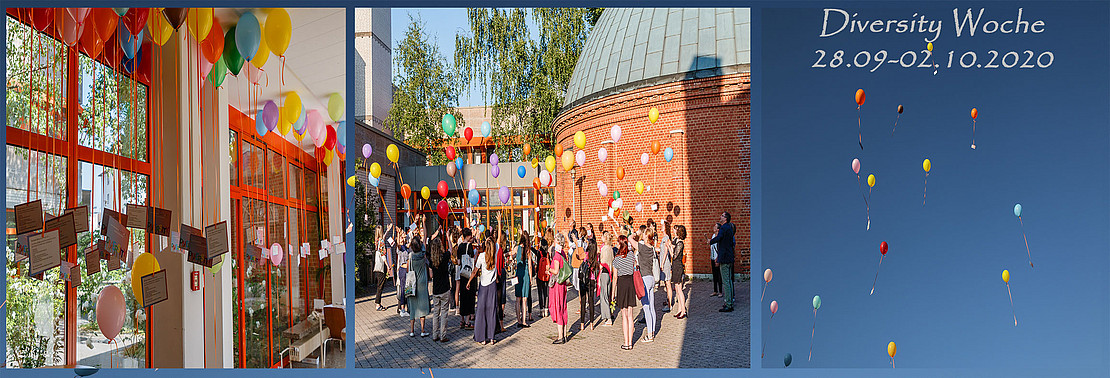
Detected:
[{"left": 4, "top": 16, "right": 68, "bottom": 140}]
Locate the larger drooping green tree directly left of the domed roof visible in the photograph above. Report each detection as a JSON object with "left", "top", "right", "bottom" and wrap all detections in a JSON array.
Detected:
[{"left": 455, "top": 8, "right": 603, "bottom": 160}]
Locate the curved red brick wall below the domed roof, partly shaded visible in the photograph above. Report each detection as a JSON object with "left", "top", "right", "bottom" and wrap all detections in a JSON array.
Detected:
[{"left": 555, "top": 73, "right": 751, "bottom": 275}]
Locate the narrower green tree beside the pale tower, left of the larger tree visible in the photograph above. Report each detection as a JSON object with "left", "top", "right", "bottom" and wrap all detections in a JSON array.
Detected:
[{"left": 386, "top": 17, "right": 462, "bottom": 165}]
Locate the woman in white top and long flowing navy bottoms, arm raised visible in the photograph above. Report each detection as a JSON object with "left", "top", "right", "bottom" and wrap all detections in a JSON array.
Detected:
[{"left": 466, "top": 239, "right": 497, "bottom": 345}]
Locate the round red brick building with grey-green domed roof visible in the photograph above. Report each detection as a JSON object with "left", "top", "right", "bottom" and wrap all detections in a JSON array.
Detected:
[{"left": 555, "top": 9, "right": 751, "bottom": 276}]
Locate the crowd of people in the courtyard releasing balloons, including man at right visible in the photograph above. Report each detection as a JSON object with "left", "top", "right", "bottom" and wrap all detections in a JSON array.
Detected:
[{"left": 372, "top": 213, "right": 736, "bottom": 350}]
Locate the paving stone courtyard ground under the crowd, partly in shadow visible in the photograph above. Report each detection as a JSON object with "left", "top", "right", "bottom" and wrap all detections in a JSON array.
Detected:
[{"left": 352, "top": 280, "right": 750, "bottom": 368}]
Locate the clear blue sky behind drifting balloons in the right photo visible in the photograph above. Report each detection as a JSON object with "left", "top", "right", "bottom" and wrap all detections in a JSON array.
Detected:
[{"left": 754, "top": 3, "right": 1110, "bottom": 372}]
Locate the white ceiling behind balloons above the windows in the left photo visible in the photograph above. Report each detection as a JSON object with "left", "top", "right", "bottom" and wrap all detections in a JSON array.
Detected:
[{"left": 215, "top": 8, "right": 347, "bottom": 152}]
